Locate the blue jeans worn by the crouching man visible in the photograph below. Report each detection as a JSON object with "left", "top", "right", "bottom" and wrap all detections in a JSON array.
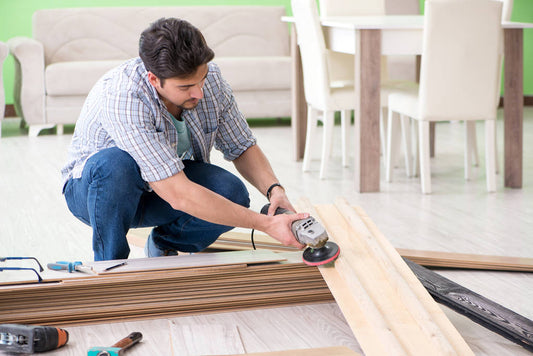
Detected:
[{"left": 63, "top": 147, "right": 250, "bottom": 261}]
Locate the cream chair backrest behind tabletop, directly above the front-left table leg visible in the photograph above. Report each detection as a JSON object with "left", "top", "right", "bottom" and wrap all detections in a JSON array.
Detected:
[{"left": 318, "top": 0, "right": 385, "bottom": 17}]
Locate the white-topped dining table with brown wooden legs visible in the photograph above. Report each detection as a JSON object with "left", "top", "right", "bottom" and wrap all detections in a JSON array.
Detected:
[{"left": 282, "top": 15, "right": 533, "bottom": 192}]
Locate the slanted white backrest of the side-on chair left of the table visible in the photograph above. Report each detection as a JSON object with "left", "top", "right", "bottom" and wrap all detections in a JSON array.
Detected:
[{"left": 291, "top": 0, "right": 330, "bottom": 108}]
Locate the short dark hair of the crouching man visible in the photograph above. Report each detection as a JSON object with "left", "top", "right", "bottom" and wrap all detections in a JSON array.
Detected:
[{"left": 139, "top": 18, "right": 215, "bottom": 84}]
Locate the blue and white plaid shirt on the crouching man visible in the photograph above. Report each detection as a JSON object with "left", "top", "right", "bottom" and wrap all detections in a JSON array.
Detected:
[{"left": 61, "top": 58, "right": 256, "bottom": 183}]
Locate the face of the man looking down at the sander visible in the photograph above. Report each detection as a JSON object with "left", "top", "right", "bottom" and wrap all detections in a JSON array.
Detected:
[{"left": 148, "top": 64, "right": 208, "bottom": 111}]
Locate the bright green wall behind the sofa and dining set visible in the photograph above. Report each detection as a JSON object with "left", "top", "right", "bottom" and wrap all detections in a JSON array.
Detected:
[{"left": 0, "top": 0, "right": 533, "bottom": 104}]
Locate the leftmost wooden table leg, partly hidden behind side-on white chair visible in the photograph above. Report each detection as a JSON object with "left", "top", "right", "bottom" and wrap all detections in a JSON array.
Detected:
[{"left": 291, "top": 25, "right": 307, "bottom": 161}]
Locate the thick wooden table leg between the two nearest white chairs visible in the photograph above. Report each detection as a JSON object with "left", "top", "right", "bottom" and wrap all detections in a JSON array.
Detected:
[{"left": 355, "top": 30, "right": 381, "bottom": 193}]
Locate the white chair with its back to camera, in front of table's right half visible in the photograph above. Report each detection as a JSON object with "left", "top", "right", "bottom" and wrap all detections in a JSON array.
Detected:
[{"left": 385, "top": 0, "right": 502, "bottom": 193}]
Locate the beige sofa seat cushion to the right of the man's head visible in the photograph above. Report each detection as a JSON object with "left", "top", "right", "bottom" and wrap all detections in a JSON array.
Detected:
[{"left": 214, "top": 56, "right": 291, "bottom": 91}]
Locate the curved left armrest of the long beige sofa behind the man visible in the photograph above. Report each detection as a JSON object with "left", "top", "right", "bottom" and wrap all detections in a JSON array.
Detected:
[{"left": 7, "top": 37, "right": 45, "bottom": 125}]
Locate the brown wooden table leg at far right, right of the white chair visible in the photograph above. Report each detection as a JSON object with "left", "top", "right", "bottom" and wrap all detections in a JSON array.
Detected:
[{"left": 503, "top": 29, "right": 524, "bottom": 188}]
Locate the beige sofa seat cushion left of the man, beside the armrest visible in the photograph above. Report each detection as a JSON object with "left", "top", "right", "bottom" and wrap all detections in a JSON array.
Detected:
[{"left": 45, "top": 60, "right": 124, "bottom": 95}]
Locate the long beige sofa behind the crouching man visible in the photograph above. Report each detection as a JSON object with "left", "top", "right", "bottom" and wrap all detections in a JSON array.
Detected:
[{"left": 8, "top": 6, "right": 291, "bottom": 136}]
